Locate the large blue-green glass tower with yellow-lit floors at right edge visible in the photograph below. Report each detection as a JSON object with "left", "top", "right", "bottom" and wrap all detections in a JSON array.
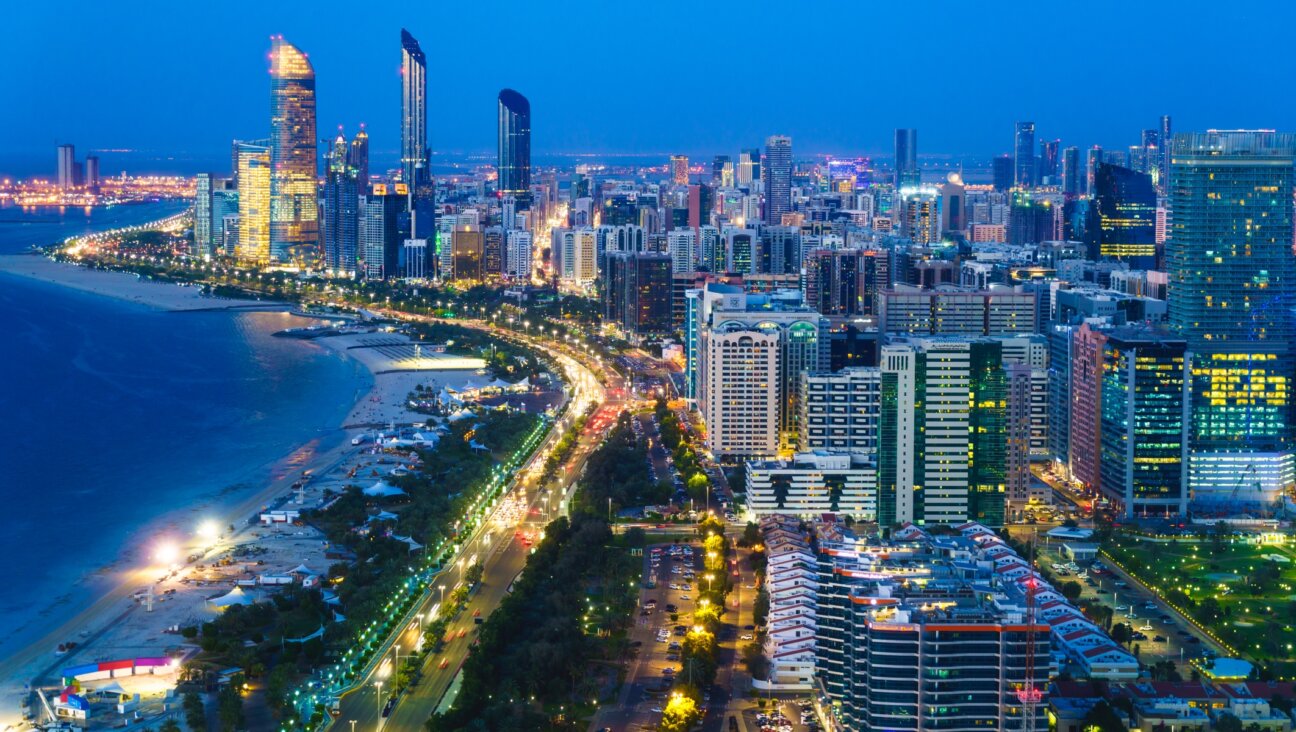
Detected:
[{"left": 1165, "top": 131, "right": 1296, "bottom": 500}]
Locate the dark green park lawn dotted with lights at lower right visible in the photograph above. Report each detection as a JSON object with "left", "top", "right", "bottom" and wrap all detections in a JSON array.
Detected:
[{"left": 1107, "top": 536, "right": 1296, "bottom": 675}]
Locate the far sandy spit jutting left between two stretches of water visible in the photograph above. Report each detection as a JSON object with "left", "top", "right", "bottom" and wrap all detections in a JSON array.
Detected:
[{"left": 0, "top": 254, "right": 290, "bottom": 311}]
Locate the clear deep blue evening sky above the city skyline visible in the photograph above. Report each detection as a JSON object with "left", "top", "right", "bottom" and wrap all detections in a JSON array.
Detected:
[{"left": 0, "top": 0, "right": 1296, "bottom": 170}]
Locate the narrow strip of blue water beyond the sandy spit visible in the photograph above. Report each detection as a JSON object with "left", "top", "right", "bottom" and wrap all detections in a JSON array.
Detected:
[{"left": 0, "top": 201, "right": 189, "bottom": 254}]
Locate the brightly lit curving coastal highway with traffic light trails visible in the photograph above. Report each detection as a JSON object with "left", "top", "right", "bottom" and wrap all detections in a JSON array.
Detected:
[{"left": 333, "top": 312, "right": 625, "bottom": 732}]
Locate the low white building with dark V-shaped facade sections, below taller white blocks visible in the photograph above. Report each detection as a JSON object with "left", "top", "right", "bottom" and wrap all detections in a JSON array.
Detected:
[{"left": 746, "top": 452, "right": 877, "bottom": 521}]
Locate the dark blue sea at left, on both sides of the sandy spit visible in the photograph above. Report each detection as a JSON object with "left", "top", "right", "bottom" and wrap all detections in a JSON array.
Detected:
[{"left": 0, "top": 203, "right": 372, "bottom": 658}]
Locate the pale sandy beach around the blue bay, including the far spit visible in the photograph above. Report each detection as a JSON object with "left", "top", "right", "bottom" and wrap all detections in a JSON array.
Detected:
[{"left": 0, "top": 255, "right": 483, "bottom": 728}]
